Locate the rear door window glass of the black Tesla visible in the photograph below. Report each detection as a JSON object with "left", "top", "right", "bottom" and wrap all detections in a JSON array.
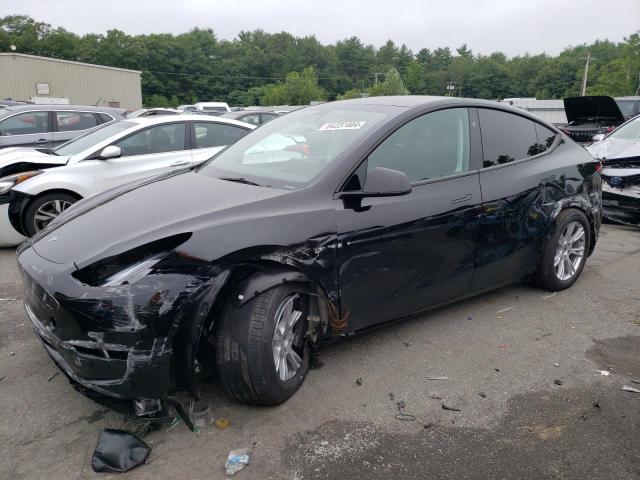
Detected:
[{"left": 478, "top": 108, "right": 553, "bottom": 167}]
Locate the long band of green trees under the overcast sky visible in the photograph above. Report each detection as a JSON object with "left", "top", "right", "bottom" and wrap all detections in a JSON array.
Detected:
[{"left": 0, "top": 15, "right": 640, "bottom": 106}]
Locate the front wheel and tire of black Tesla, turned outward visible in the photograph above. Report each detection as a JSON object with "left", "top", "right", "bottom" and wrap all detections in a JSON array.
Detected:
[{"left": 215, "top": 285, "right": 310, "bottom": 405}]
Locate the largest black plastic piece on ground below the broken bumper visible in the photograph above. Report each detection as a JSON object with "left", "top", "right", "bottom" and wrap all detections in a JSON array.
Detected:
[{"left": 91, "top": 428, "right": 151, "bottom": 473}]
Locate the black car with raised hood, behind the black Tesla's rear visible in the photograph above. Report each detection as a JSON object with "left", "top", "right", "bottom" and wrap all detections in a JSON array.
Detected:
[{"left": 560, "top": 96, "right": 625, "bottom": 143}]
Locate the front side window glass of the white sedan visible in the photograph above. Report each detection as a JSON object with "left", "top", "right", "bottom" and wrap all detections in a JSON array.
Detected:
[{"left": 114, "top": 123, "right": 186, "bottom": 157}]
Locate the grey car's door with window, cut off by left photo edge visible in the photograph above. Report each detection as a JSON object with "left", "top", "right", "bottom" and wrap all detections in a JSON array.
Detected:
[{"left": 0, "top": 106, "right": 53, "bottom": 148}]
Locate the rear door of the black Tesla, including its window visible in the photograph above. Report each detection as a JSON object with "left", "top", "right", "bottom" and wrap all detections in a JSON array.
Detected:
[{"left": 472, "top": 108, "right": 565, "bottom": 290}]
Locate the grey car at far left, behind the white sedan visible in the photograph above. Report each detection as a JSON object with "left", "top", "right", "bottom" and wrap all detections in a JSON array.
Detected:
[{"left": 0, "top": 105, "right": 124, "bottom": 148}]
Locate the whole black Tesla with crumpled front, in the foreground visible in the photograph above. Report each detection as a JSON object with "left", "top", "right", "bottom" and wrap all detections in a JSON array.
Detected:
[{"left": 18, "top": 96, "right": 601, "bottom": 415}]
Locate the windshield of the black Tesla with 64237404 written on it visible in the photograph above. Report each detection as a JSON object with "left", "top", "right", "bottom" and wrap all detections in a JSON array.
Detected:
[{"left": 201, "top": 104, "right": 397, "bottom": 189}]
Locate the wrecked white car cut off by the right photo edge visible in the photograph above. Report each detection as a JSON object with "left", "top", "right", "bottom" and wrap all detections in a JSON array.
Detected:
[{"left": 587, "top": 117, "right": 640, "bottom": 226}]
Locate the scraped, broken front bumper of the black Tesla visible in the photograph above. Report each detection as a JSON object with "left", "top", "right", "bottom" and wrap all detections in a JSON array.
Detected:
[{"left": 18, "top": 244, "right": 226, "bottom": 415}]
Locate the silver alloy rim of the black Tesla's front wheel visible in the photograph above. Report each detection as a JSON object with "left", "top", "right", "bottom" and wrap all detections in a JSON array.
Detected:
[{"left": 271, "top": 293, "right": 302, "bottom": 381}]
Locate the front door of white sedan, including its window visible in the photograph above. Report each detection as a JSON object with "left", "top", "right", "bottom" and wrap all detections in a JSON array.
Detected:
[{"left": 94, "top": 122, "right": 191, "bottom": 191}]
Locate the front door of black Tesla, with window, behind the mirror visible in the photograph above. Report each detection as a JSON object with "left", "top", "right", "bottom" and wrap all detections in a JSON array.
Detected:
[{"left": 336, "top": 108, "right": 480, "bottom": 331}]
